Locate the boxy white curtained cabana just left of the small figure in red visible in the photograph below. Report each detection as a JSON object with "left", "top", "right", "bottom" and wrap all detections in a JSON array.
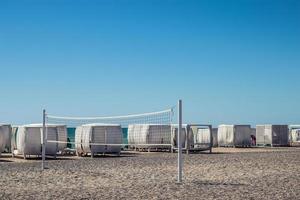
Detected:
[{"left": 218, "top": 125, "right": 251, "bottom": 147}]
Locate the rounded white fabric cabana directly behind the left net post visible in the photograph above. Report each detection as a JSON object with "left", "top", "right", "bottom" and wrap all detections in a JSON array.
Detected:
[{"left": 13, "top": 124, "right": 67, "bottom": 159}]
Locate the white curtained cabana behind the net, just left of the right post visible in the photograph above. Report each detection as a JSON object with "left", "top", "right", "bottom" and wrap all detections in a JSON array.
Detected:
[{"left": 128, "top": 124, "right": 172, "bottom": 150}]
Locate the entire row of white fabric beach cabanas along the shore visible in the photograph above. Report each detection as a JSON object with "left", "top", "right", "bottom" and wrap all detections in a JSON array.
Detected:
[{"left": 0, "top": 124, "right": 300, "bottom": 159}]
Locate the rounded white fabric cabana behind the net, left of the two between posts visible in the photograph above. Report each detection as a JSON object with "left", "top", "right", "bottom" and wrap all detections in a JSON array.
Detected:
[{"left": 75, "top": 124, "right": 122, "bottom": 157}]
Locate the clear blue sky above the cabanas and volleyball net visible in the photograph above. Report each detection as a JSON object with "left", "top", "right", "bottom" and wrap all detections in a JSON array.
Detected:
[{"left": 0, "top": 0, "right": 300, "bottom": 125}]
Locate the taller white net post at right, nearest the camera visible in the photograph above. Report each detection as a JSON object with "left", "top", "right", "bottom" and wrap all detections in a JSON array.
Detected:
[{"left": 177, "top": 100, "right": 182, "bottom": 184}]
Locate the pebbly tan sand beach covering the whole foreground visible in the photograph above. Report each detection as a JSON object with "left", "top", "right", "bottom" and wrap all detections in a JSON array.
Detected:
[{"left": 0, "top": 148, "right": 300, "bottom": 199}]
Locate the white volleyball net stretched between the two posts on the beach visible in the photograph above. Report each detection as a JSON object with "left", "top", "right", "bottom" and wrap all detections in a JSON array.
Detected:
[{"left": 45, "top": 107, "right": 176, "bottom": 156}]
